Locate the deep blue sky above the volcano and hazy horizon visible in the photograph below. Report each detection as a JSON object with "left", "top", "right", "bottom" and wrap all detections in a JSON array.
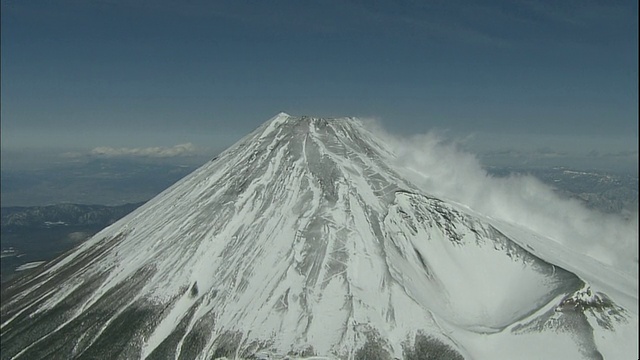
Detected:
[{"left": 1, "top": 0, "right": 638, "bottom": 170}]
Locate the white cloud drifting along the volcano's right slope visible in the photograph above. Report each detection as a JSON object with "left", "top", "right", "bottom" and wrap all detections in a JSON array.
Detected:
[{"left": 371, "top": 121, "right": 638, "bottom": 274}]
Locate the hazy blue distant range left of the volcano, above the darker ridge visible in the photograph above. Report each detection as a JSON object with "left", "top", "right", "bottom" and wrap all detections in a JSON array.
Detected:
[{"left": 0, "top": 159, "right": 198, "bottom": 206}]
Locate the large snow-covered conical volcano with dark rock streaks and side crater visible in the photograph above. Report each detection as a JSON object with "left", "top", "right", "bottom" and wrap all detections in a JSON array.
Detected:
[{"left": 1, "top": 113, "right": 638, "bottom": 359}]
